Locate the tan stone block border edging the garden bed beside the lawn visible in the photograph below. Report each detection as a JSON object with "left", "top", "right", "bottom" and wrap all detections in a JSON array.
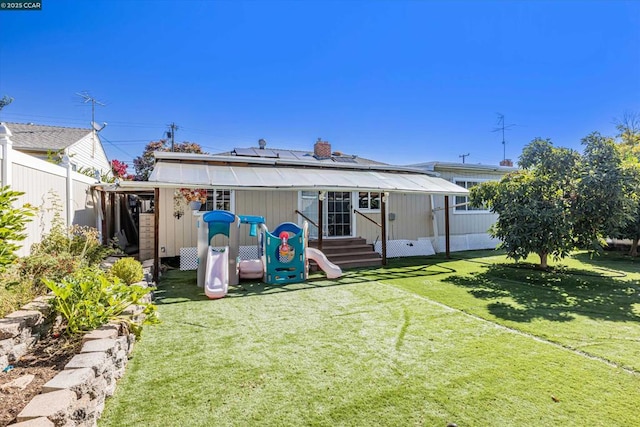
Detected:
[{"left": 0, "top": 260, "right": 153, "bottom": 427}]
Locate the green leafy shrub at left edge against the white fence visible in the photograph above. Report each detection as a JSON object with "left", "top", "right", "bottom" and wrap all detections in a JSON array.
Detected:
[{"left": 0, "top": 186, "right": 35, "bottom": 269}]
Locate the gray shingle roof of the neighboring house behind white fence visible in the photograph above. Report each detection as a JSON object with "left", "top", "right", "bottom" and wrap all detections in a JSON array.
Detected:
[{"left": 5, "top": 122, "right": 92, "bottom": 151}]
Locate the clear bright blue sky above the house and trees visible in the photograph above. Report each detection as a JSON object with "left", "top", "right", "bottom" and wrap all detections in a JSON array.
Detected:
[{"left": 0, "top": 0, "right": 640, "bottom": 171}]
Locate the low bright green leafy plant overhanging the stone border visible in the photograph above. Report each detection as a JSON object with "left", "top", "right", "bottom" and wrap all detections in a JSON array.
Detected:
[{"left": 43, "top": 267, "right": 157, "bottom": 335}]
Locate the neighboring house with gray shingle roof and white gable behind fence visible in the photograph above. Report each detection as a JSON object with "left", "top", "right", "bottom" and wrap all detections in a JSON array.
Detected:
[{"left": 5, "top": 122, "right": 111, "bottom": 174}]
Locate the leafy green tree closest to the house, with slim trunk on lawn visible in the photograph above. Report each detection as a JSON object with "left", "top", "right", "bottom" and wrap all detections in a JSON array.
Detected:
[{"left": 471, "top": 138, "right": 578, "bottom": 268}]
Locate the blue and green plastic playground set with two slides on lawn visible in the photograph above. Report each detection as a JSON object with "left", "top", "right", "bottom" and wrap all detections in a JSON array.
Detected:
[{"left": 197, "top": 210, "right": 342, "bottom": 299}]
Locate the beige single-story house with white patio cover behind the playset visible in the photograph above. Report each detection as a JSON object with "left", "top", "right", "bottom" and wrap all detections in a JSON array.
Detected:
[{"left": 99, "top": 141, "right": 468, "bottom": 278}]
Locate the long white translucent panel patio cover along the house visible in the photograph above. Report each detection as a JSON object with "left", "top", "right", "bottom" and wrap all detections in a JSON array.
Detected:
[{"left": 149, "top": 161, "right": 469, "bottom": 196}]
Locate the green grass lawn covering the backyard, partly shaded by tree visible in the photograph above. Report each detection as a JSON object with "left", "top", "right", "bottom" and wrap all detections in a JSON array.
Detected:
[{"left": 100, "top": 252, "right": 640, "bottom": 427}]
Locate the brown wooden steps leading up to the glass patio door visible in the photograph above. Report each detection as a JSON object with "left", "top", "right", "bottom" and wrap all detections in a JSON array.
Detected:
[{"left": 309, "top": 237, "right": 382, "bottom": 271}]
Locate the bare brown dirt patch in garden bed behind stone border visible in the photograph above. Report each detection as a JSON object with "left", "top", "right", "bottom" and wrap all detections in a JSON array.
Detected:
[{"left": 0, "top": 336, "right": 82, "bottom": 426}]
